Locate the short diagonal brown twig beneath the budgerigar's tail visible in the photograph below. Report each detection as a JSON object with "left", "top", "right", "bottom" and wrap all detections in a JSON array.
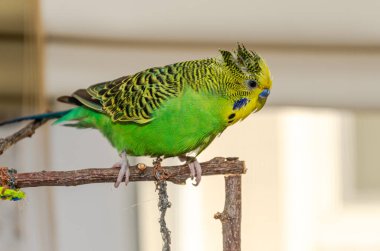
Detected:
[{"left": 0, "top": 119, "right": 48, "bottom": 155}]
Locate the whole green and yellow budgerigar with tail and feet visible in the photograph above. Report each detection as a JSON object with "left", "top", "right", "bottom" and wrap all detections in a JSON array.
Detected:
[{"left": 0, "top": 44, "right": 272, "bottom": 187}]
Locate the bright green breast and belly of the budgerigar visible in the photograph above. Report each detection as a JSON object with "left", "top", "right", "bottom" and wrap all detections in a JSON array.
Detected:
[{"left": 78, "top": 88, "right": 230, "bottom": 157}]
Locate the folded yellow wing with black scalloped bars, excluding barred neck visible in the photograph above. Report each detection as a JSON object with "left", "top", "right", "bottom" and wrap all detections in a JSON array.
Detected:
[{"left": 84, "top": 65, "right": 183, "bottom": 123}]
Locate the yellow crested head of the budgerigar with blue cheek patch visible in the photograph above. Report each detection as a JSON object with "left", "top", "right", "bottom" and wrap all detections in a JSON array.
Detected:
[{"left": 220, "top": 44, "right": 272, "bottom": 118}]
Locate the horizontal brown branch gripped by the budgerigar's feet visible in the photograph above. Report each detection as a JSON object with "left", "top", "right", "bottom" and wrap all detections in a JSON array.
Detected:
[{"left": 11, "top": 157, "right": 246, "bottom": 188}]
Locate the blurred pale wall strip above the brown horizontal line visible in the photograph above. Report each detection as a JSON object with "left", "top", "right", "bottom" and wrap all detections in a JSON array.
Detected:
[{"left": 42, "top": 0, "right": 380, "bottom": 46}]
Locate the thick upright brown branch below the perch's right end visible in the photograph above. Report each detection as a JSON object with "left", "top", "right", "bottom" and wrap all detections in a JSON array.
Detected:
[{"left": 214, "top": 175, "right": 241, "bottom": 251}]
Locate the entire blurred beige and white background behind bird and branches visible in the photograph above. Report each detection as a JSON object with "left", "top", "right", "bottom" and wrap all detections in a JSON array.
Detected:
[{"left": 0, "top": 0, "right": 380, "bottom": 251}]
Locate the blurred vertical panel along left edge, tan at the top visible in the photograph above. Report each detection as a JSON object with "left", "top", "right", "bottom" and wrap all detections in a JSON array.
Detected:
[{"left": 0, "top": 0, "right": 55, "bottom": 251}]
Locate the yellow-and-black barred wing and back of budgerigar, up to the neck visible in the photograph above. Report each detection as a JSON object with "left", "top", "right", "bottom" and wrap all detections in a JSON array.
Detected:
[{"left": 59, "top": 59, "right": 215, "bottom": 124}]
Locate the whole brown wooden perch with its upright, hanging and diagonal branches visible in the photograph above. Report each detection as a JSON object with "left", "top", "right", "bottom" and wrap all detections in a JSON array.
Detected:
[{"left": 0, "top": 120, "right": 246, "bottom": 251}]
